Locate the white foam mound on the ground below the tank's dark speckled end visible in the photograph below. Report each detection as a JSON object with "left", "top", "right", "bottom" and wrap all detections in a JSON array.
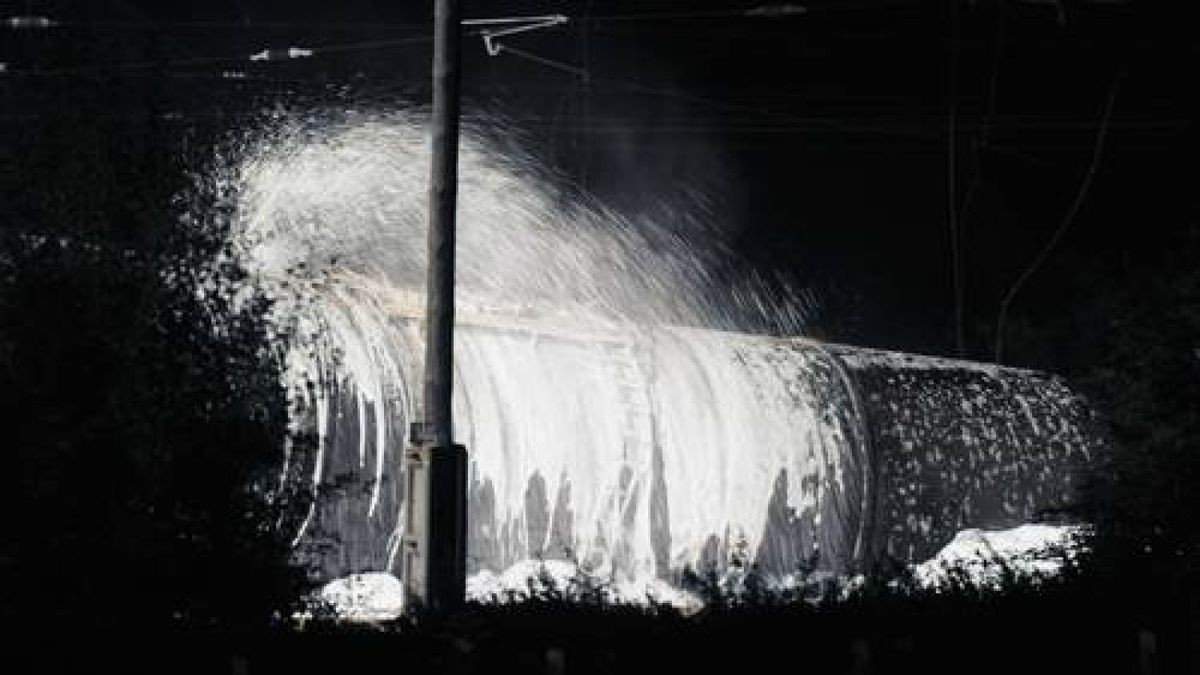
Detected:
[{"left": 912, "top": 525, "right": 1084, "bottom": 589}]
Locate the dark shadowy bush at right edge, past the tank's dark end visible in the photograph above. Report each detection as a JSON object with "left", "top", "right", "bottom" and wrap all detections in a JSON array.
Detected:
[{"left": 1062, "top": 235, "right": 1200, "bottom": 668}]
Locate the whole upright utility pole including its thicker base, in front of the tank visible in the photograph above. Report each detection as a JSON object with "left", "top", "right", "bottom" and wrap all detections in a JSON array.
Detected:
[{"left": 403, "top": 0, "right": 467, "bottom": 611}]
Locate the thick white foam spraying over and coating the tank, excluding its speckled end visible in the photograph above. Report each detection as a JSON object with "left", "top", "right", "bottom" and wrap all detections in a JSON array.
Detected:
[{"left": 236, "top": 112, "right": 859, "bottom": 593}]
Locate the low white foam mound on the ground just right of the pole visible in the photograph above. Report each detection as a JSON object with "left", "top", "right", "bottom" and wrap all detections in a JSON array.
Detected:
[{"left": 467, "top": 560, "right": 703, "bottom": 611}]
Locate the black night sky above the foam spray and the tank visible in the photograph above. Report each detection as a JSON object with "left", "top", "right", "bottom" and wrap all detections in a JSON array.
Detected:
[{"left": 0, "top": 0, "right": 1200, "bottom": 351}]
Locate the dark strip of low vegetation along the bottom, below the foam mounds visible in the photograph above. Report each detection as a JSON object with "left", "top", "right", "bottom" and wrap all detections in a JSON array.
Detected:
[{"left": 2, "top": 562, "right": 1180, "bottom": 674}]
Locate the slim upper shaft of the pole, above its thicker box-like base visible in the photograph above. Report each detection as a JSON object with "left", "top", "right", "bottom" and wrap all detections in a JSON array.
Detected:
[{"left": 425, "top": 0, "right": 461, "bottom": 447}]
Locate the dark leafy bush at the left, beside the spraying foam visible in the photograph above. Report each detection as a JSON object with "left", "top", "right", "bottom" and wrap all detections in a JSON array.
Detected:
[{"left": 0, "top": 65, "right": 314, "bottom": 631}]
